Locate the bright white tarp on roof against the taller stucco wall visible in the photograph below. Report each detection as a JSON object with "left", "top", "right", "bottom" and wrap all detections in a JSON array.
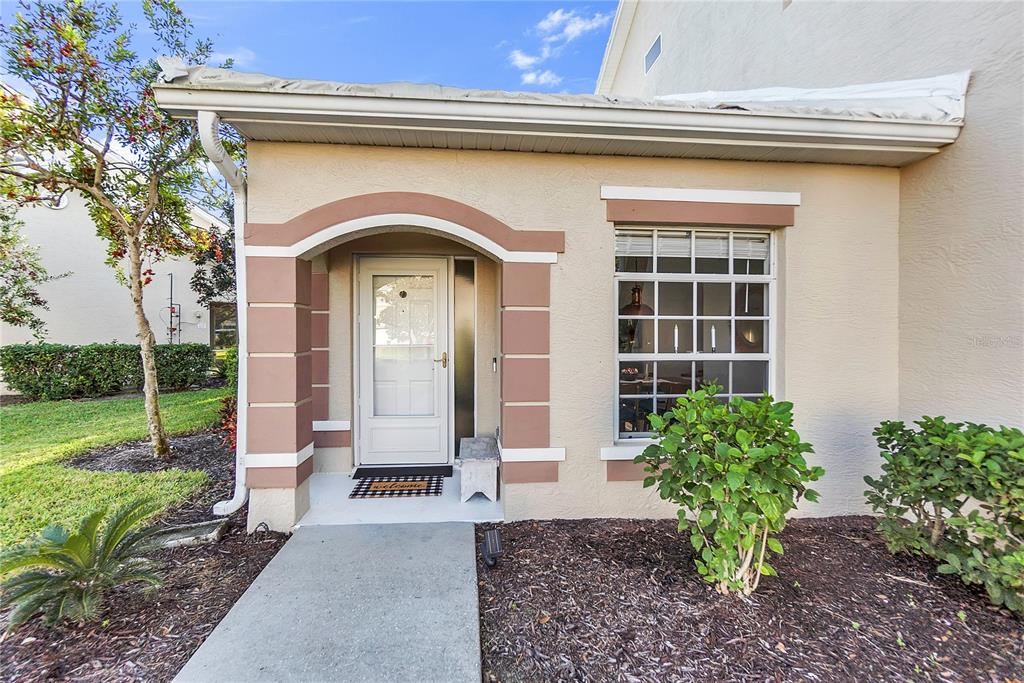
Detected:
[{"left": 654, "top": 71, "right": 971, "bottom": 123}]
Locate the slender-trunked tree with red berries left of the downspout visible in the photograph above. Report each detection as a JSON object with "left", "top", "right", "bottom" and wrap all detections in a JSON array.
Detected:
[{"left": 0, "top": 0, "right": 211, "bottom": 458}]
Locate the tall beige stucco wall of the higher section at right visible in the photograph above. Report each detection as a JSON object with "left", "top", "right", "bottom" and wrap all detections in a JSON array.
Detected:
[{"left": 609, "top": 0, "right": 1024, "bottom": 425}]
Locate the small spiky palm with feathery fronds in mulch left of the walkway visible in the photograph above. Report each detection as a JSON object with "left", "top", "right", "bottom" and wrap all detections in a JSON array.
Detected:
[{"left": 0, "top": 501, "right": 160, "bottom": 631}]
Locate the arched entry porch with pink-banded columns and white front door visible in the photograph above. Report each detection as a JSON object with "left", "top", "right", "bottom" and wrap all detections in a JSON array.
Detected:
[{"left": 240, "top": 193, "right": 564, "bottom": 530}]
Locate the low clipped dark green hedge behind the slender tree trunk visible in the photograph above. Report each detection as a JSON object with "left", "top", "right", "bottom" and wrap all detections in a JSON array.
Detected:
[{"left": 0, "top": 344, "right": 213, "bottom": 400}]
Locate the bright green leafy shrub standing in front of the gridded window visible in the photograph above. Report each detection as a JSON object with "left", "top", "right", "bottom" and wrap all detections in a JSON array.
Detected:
[{"left": 635, "top": 385, "right": 824, "bottom": 595}]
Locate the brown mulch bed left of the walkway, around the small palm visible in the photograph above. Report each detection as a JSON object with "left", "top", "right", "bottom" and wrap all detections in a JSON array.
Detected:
[{"left": 0, "top": 432, "right": 288, "bottom": 683}]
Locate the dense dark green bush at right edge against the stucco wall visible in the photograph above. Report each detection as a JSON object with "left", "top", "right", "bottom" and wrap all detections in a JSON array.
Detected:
[{"left": 864, "top": 417, "right": 1024, "bottom": 611}]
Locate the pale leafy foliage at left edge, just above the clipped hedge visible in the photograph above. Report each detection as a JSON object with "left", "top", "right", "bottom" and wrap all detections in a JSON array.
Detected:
[{"left": 0, "top": 202, "right": 68, "bottom": 341}]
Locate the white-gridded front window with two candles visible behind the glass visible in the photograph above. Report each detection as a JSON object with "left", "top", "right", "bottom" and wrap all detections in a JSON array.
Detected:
[{"left": 615, "top": 228, "right": 772, "bottom": 438}]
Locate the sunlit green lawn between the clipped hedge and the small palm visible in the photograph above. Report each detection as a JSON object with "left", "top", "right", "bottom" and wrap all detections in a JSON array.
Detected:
[{"left": 0, "top": 389, "right": 228, "bottom": 547}]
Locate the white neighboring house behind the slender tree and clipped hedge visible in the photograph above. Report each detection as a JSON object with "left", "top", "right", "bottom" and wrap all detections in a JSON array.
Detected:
[{"left": 0, "top": 193, "right": 236, "bottom": 345}]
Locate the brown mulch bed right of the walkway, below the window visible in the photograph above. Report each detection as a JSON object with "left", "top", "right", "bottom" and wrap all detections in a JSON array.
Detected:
[{"left": 477, "top": 517, "right": 1024, "bottom": 683}]
